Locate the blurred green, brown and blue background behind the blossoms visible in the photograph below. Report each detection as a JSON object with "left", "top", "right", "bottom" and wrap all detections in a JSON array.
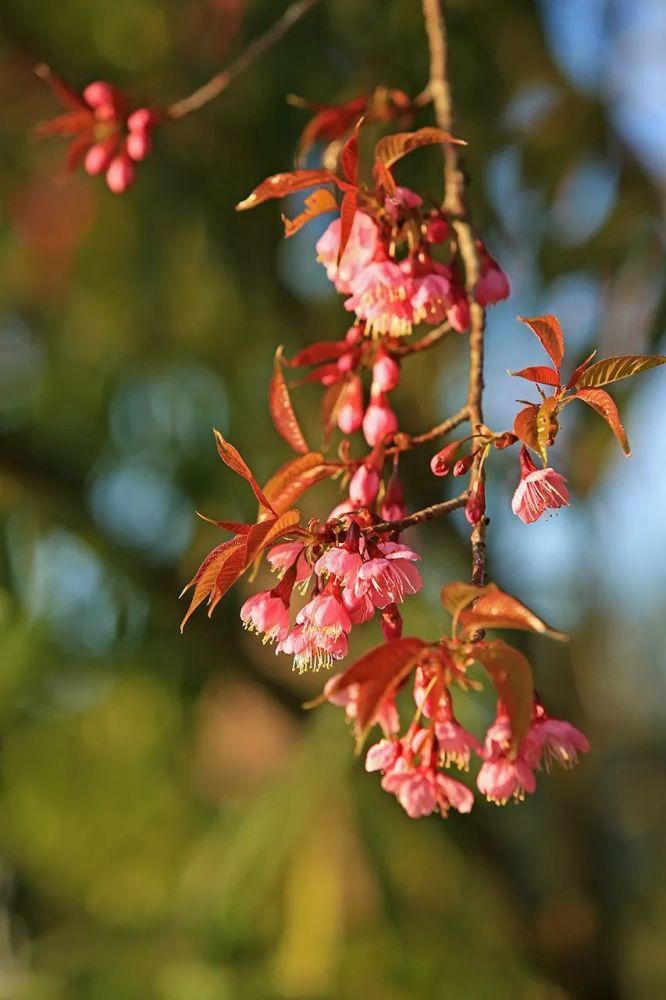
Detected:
[{"left": 0, "top": 0, "right": 666, "bottom": 1000}]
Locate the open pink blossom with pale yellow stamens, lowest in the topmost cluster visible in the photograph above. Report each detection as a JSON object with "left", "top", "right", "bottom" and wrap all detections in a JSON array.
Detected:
[{"left": 345, "top": 260, "right": 412, "bottom": 337}]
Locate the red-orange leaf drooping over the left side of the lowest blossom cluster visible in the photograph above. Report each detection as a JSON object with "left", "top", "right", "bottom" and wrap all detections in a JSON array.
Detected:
[{"left": 328, "top": 637, "right": 427, "bottom": 747}]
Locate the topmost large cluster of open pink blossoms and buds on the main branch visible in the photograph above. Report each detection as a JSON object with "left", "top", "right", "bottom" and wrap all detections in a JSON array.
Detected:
[{"left": 317, "top": 187, "right": 510, "bottom": 337}]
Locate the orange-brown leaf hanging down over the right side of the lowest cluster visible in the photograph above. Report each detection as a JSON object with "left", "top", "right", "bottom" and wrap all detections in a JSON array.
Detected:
[{"left": 473, "top": 639, "right": 534, "bottom": 754}]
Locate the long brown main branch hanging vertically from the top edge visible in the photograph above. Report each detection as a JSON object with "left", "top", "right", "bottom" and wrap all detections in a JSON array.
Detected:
[{"left": 423, "top": 0, "right": 486, "bottom": 586}]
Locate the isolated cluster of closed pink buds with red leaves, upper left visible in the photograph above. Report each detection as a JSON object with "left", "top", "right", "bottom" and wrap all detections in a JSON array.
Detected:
[{"left": 38, "top": 67, "right": 160, "bottom": 194}]
